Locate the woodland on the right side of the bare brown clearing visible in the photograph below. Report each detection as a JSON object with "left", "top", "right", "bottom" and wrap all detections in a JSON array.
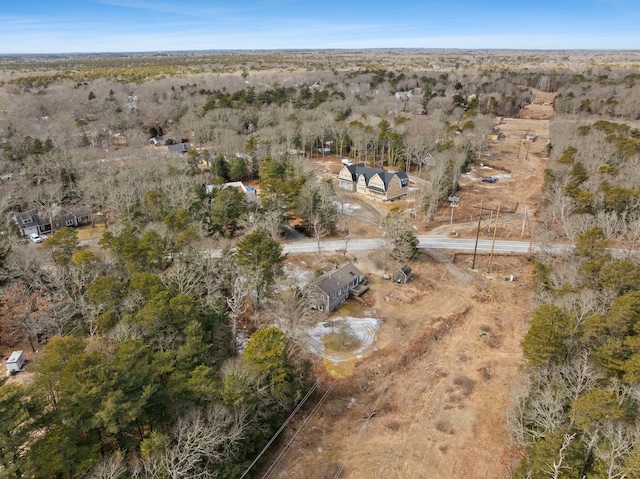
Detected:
[{"left": 508, "top": 62, "right": 640, "bottom": 479}]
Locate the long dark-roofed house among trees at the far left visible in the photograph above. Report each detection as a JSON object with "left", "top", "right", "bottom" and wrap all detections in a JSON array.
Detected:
[{"left": 13, "top": 206, "right": 93, "bottom": 236}]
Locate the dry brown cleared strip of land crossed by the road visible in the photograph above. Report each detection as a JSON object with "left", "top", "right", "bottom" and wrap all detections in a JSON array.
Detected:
[{"left": 260, "top": 94, "right": 553, "bottom": 479}]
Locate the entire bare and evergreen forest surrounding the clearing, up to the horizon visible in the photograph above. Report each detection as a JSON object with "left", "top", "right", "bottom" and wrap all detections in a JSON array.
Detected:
[{"left": 0, "top": 50, "right": 640, "bottom": 479}]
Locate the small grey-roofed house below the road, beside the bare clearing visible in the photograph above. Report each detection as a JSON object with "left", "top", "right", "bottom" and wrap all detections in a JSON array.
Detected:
[{"left": 314, "top": 263, "right": 369, "bottom": 313}]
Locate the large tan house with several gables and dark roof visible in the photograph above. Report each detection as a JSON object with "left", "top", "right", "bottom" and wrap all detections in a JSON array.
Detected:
[{"left": 338, "top": 163, "right": 409, "bottom": 201}]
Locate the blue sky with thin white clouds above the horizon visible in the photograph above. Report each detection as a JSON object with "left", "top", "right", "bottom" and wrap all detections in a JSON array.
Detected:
[{"left": 0, "top": 0, "right": 640, "bottom": 54}]
